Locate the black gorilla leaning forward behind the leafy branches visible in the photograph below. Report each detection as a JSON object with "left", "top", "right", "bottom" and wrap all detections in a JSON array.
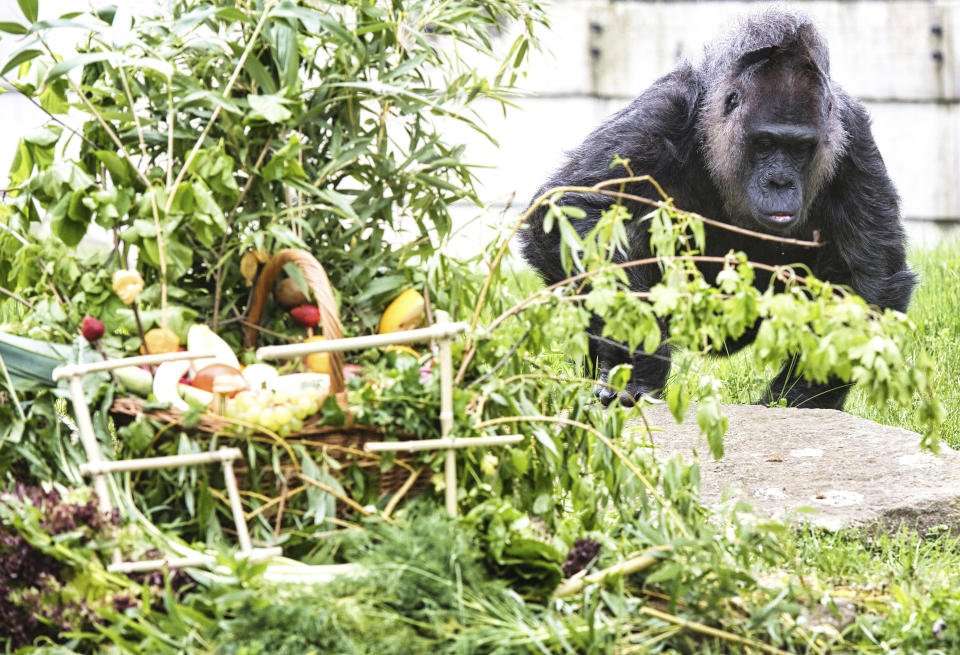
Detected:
[{"left": 520, "top": 10, "right": 916, "bottom": 408}]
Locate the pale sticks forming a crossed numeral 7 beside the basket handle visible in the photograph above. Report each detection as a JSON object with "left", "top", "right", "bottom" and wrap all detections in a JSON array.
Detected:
[{"left": 257, "top": 311, "right": 524, "bottom": 516}]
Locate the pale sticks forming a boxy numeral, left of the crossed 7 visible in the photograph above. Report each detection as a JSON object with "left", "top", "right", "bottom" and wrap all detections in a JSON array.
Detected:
[{"left": 53, "top": 351, "right": 282, "bottom": 572}]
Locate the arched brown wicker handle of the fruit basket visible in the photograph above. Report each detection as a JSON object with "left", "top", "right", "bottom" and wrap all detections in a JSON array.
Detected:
[{"left": 243, "top": 248, "right": 344, "bottom": 393}]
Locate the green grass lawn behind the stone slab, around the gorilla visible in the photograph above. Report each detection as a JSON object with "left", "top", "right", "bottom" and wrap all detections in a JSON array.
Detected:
[{"left": 670, "top": 241, "right": 960, "bottom": 448}]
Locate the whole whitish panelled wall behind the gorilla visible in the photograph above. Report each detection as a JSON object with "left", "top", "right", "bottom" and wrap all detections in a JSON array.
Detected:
[{"left": 450, "top": 0, "right": 960, "bottom": 252}]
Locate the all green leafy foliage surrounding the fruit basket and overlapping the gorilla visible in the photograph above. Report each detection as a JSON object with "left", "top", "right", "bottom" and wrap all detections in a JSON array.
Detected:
[{"left": 0, "top": 0, "right": 955, "bottom": 654}]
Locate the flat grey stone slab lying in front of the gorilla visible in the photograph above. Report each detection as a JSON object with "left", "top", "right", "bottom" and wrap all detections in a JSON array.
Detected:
[{"left": 633, "top": 404, "right": 960, "bottom": 534}]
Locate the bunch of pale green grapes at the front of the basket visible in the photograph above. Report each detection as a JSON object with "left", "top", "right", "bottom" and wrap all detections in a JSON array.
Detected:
[{"left": 224, "top": 387, "right": 320, "bottom": 437}]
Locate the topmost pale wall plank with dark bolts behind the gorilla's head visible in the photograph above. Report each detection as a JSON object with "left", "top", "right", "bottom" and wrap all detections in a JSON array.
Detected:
[{"left": 586, "top": 0, "right": 960, "bottom": 101}]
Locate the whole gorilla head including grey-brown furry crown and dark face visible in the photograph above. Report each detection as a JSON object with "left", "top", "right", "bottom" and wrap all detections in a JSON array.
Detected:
[{"left": 698, "top": 13, "right": 846, "bottom": 234}]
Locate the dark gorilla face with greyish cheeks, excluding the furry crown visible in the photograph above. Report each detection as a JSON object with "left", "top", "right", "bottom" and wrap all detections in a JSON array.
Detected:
[{"left": 704, "top": 51, "right": 842, "bottom": 235}]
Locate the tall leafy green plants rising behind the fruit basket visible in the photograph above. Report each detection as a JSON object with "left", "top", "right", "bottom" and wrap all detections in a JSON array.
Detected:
[{"left": 0, "top": 0, "right": 543, "bottom": 346}]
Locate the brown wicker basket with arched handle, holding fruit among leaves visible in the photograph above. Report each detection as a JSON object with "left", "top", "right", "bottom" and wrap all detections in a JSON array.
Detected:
[{"left": 112, "top": 249, "right": 429, "bottom": 495}]
